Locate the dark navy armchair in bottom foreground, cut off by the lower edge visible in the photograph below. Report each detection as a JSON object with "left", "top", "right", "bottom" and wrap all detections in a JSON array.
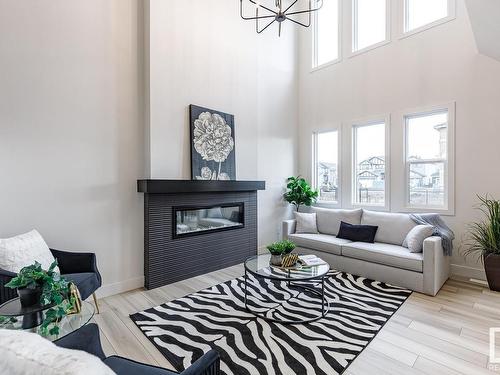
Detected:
[{"left": 54, "top": 323, "right": 220, "bottom": 375}]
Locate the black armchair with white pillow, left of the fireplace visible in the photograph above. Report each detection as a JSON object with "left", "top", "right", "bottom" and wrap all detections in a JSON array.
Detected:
[{"left": 0, "top": 249, "right": 102, "bottom": 313}]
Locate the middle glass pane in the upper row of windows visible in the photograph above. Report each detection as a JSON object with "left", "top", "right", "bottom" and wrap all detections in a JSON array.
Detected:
[{"left": 353, "top": 0, "right": 386, "bottom": 51}]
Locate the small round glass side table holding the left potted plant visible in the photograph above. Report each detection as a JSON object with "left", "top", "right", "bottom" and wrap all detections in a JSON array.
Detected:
[{"left": 0, "top": 298, "right": 95, "bottom": 341}]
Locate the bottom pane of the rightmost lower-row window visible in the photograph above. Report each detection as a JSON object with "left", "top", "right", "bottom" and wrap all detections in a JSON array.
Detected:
[{"left": 408, "top": 162, "right": 445, "bottom": 207}]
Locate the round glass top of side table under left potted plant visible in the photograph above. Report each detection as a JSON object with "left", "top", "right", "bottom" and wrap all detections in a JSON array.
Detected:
[{"left": 0, "top": 301, "right": 95, "bottom": 341}]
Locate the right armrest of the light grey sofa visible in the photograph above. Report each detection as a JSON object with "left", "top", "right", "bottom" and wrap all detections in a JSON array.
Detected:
[{"left": 423, "top": 236, "right": 450, "bottom": 296}]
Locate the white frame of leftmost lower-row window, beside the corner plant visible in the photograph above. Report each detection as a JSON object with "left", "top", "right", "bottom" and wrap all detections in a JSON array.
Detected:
[{"left": 311, "top": 126, "right": 343, "bottom": 208}]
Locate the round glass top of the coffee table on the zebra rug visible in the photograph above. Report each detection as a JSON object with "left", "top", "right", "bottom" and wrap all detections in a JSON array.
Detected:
[{"left": 245, "top": 254, "right": 330, "bottom": 281}]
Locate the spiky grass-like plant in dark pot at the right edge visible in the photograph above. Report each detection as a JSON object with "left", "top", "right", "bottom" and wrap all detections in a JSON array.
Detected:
[{"left": 465, "top": 196, "right": 500, "bottom": 291}]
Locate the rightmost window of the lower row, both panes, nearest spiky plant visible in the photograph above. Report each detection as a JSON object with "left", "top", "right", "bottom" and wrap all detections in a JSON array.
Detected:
[{"left": 405, "top": 110, "right": 449, "bottom": 209}]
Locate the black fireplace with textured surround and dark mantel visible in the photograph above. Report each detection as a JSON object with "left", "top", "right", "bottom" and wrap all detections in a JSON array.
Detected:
[{"left": 138, "top": 180, "right": 265, "bottom": 289}]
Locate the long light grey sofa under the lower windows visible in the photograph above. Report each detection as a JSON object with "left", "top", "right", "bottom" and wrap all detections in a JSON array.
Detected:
[{"left": 283, "top": 207, "right": 450, "bottom": 296}]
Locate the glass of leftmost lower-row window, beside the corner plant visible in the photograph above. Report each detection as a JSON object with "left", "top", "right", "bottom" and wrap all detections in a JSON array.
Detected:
[{"left": 316, "top": 131, "right": 339, "bottom": 203}]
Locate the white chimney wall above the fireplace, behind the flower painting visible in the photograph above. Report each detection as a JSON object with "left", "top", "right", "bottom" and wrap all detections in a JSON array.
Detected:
[{"left": 148, "top": 0, "right": 298, "bottom": 246}]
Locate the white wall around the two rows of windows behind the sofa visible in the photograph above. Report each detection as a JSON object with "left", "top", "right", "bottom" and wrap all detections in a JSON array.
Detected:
[{"left": 299, "top": 0, "right": 500, "bottom": 277}]
